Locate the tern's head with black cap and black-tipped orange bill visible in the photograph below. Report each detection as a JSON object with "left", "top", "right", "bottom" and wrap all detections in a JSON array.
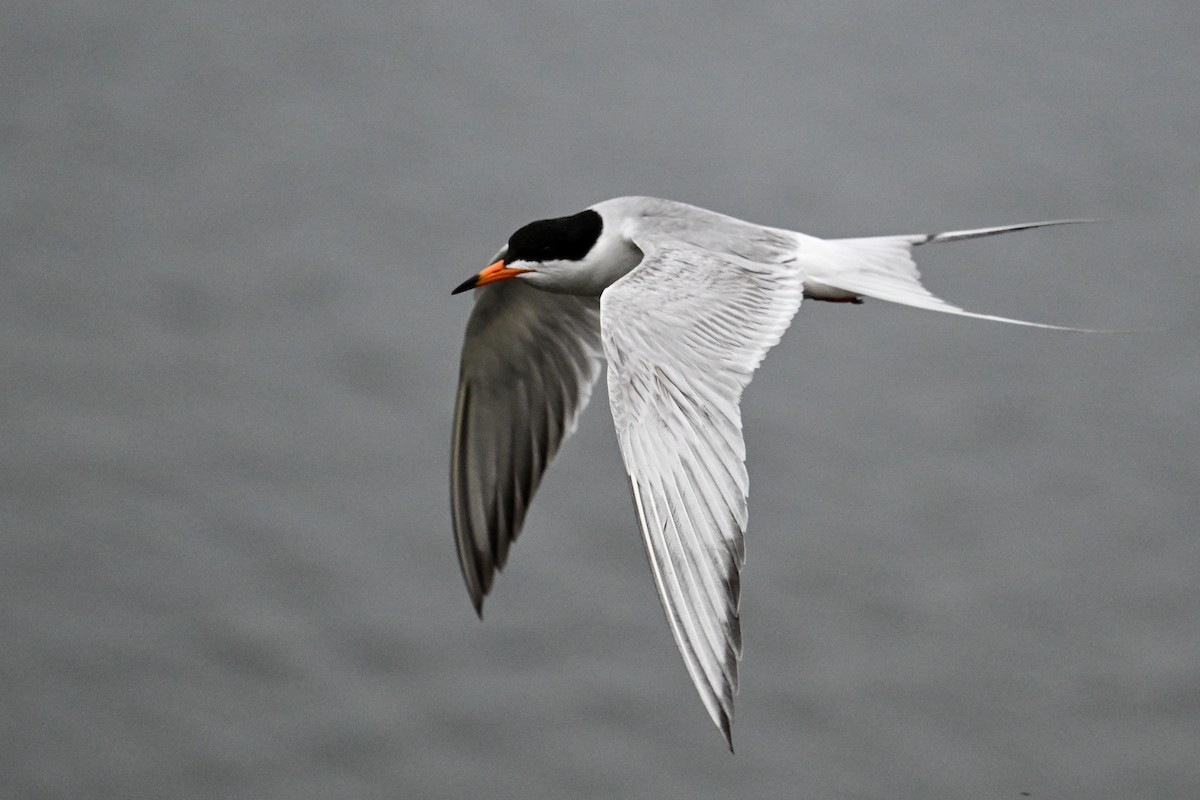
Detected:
[{"left": 451, "top": 209, "right": 641, "bottom": 295}]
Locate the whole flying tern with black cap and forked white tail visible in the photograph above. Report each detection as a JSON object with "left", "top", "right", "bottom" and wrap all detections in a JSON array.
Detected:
[{"left": 450, "top": 197, "right": 1087, "bottom": 750}]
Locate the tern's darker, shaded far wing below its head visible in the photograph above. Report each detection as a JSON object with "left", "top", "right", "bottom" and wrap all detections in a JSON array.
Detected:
[{"left": 450, "top": 281, "right": 601, "bottom": 613}]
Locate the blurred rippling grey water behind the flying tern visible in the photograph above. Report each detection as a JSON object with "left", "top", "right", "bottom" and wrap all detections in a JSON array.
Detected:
[{"left": 0, "top": 0, "right": 1200, "bottom": 799}]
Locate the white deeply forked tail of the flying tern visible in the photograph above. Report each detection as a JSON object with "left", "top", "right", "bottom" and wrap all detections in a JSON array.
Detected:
[{"left": 797, "top": 219, "right": 1097, "bottom": 332}]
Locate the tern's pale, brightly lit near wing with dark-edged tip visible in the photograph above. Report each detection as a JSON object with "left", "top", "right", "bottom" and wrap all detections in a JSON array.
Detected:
[{"left": 600, "top": 240, "right": 802, "bottom": 740}]
